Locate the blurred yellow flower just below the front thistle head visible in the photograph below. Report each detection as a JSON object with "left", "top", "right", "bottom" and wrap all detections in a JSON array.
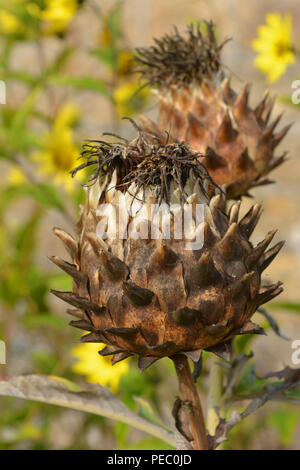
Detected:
[{"left": 71, "top": 343, "right": 129, "bottom": 393}]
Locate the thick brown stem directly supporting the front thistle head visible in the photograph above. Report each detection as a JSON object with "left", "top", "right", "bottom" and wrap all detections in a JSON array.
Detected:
[{"left": 172, "top": 355, "right": 209, "bottom": 450}]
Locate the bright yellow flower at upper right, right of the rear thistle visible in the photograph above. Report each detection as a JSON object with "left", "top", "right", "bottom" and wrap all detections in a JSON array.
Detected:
[{"left": 252, "top": 13, "right": 295, "bottom": 83}]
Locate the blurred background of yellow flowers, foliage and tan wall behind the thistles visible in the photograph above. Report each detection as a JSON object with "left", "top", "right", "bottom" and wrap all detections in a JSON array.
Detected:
[{"left": 0, "top": 0, "right": 300, "bottom": 449}]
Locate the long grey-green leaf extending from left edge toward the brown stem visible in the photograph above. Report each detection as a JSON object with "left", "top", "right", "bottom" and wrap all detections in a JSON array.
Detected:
[{"left": 0, "top": 375, "right": 175, "bottom": 447}]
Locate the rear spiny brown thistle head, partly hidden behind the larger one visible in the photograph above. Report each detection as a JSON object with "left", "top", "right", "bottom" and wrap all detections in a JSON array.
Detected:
[{"left": 137, "top": 23, "right": 290, "bottom": 199}]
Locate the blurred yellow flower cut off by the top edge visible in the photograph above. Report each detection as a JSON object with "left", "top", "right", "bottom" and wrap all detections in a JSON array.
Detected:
[{"left": 41, "top": 0, "right": 78, "bottom": 34}]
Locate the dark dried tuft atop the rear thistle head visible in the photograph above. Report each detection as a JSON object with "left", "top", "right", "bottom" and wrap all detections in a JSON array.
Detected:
[{"left": 136, "top": 21, "right": 227, "bottom": 87}]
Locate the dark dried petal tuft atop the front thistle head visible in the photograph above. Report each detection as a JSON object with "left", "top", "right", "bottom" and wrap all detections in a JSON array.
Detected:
[{"left": 71, "top": 125, "right": 221, "bottom": 202}]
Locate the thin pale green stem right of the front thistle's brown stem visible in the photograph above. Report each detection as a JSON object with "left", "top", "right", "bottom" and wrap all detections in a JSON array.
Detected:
[{"left": 207, "top": 360, "right": 223, "bottom": 436}]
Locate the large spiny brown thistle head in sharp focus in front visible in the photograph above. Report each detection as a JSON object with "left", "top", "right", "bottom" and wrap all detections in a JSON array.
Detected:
[{"left": 52, "top": 131, "right": 282, "bottom": 369}]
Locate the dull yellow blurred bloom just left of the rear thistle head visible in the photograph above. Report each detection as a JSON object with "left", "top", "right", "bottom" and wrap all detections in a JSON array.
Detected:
[{"left": 113, "top": 81, "right": 149, "bottom": 117}]
